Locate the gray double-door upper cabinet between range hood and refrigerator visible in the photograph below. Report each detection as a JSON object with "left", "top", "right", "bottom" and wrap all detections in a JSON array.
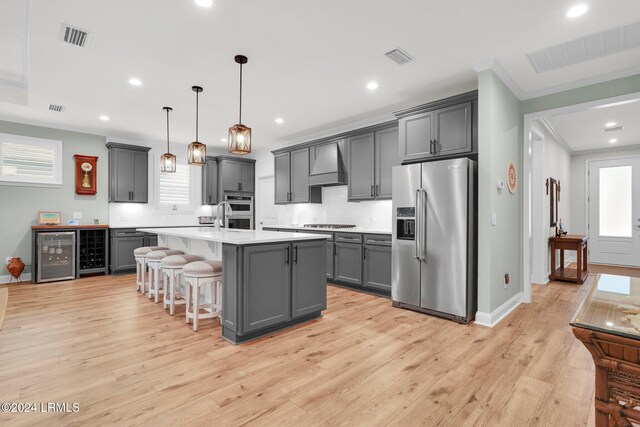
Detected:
[{"left": 347, "top": 126, "right": 400, "bottom": 201}]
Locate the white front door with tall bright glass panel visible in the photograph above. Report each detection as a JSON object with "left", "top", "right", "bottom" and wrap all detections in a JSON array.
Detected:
[{"left": 588, "top": 157, "right": 640, "bottom": 267}]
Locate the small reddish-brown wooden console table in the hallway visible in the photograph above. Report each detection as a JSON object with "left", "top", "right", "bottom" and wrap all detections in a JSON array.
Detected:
[{"left": 549, "top": 234, "right": 589, "bottom": 284}]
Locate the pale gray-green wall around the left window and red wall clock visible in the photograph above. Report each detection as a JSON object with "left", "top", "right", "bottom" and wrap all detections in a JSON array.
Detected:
[{"left": 0, "top": 121, "right": 109, "bottom": 275}]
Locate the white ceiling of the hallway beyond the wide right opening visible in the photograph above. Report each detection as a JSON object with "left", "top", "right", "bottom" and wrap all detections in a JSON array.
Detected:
[{"left": 547, "top": 101, "right": 640, "bottom": 151}]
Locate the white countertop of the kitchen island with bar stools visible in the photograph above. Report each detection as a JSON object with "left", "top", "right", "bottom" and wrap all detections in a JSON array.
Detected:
[{"left": 137, "top": 227, "right": 327, "bottom": 245}]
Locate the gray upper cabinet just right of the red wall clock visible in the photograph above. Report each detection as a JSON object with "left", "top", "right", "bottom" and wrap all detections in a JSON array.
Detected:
[{"left": 107, "top": 142, "right": 150, "bottom": 203}]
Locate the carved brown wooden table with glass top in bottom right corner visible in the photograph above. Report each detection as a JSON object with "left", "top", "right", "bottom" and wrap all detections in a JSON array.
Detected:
[{"left": 570, "top": 274, "right": 640, "bottom": 427}]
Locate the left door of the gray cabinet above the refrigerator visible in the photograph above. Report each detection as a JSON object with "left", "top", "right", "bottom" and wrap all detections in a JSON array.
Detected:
[{"left": 398, "top": 111, "right": 433, "bottom": 160}]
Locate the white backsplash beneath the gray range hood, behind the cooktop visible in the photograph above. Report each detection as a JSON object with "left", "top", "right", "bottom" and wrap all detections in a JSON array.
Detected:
[{"left": 276, "top": 185, "right": 392, "bottom": 230}]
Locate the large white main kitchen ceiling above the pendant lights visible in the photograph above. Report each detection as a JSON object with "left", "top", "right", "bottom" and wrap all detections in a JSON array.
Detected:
[{"left": 0, "top": 0, "right": 640, "bottom": 149}]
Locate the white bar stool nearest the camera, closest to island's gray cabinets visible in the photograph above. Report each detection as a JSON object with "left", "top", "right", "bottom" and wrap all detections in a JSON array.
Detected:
[{"left": 182, "top": 260, "right": 222, "bottom": 332}]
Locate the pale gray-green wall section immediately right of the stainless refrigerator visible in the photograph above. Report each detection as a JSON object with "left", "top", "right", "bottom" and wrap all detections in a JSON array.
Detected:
[{"left": 478, "top": 70, "right": 522, "bottom": 313}]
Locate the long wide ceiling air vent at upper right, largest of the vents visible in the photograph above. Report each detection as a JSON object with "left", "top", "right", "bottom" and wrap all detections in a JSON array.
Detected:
[{"left": 527, "top": 22, "right": 640, "bottom": 73}]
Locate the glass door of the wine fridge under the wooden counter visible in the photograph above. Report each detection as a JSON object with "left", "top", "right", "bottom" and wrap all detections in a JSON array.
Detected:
[{"left": 37, "top": 231, "right": 76, "bottom": 282}]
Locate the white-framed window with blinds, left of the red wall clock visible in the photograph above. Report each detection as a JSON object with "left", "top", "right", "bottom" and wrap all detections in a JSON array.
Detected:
[{"left": 0, "top": 133, "right": 62, "bottom": 186}]
